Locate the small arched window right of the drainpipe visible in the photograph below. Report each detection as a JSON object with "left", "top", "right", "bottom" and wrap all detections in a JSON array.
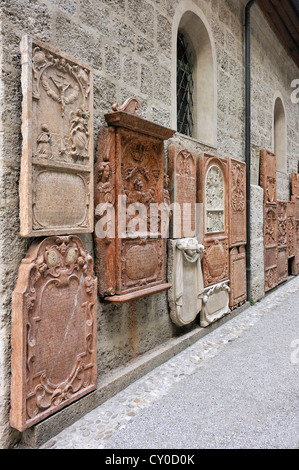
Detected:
[{"left": 273, "top": 94, "right": 287, "bottom": 173}]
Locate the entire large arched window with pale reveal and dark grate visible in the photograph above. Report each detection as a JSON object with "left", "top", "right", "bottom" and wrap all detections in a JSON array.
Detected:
[{"left": 171, "top": 0, "right": 217, "bottom": 146}]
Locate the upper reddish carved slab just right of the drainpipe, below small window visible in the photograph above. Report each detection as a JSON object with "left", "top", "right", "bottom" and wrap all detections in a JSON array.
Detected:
[{"left": 260, "top": 149, "right": 277, "bottom": 204}]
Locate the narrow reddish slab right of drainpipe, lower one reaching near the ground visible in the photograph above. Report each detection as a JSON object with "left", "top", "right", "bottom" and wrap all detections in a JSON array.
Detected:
[{"left": 264, "top": 204, "right": 278, "bottom": 292}]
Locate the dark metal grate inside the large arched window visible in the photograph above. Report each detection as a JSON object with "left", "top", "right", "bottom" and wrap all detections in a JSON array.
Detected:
[{"left": 177, "top": 31, "right": 194, "bottom": 137}]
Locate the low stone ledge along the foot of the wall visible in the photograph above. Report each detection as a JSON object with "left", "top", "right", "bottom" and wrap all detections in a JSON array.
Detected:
[{"left": 15, "top": 302, "right": 250, "bottom": 449}]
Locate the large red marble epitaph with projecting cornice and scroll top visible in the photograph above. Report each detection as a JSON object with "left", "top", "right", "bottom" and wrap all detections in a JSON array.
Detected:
[{"left": 95, "top": 97, "right": 174, "bottom": 303}]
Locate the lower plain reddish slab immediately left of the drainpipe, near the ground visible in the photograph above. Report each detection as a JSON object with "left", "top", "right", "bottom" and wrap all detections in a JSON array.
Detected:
[{"left": 229, "top": 246, "right": 247, "bottom": 310}]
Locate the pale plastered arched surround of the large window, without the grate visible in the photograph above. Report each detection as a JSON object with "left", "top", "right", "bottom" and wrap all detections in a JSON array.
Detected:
[{"left": 172, "top": 0, "right": 217, "bottom": 146}]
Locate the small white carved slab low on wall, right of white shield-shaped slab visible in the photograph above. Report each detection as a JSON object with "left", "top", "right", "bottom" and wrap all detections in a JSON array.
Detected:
[{"left": 200, "top": 281, "right": 230, "bottom": 328}]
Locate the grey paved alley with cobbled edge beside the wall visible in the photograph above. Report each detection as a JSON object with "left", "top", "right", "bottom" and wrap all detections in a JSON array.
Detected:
[{"left": 42, "top": 276, "right": 299, "bottom": 449}]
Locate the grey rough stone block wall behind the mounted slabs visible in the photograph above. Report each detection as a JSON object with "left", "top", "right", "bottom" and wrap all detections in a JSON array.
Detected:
[{"left": 0, "top": 0, "right": 299, "bottom": 447}]
